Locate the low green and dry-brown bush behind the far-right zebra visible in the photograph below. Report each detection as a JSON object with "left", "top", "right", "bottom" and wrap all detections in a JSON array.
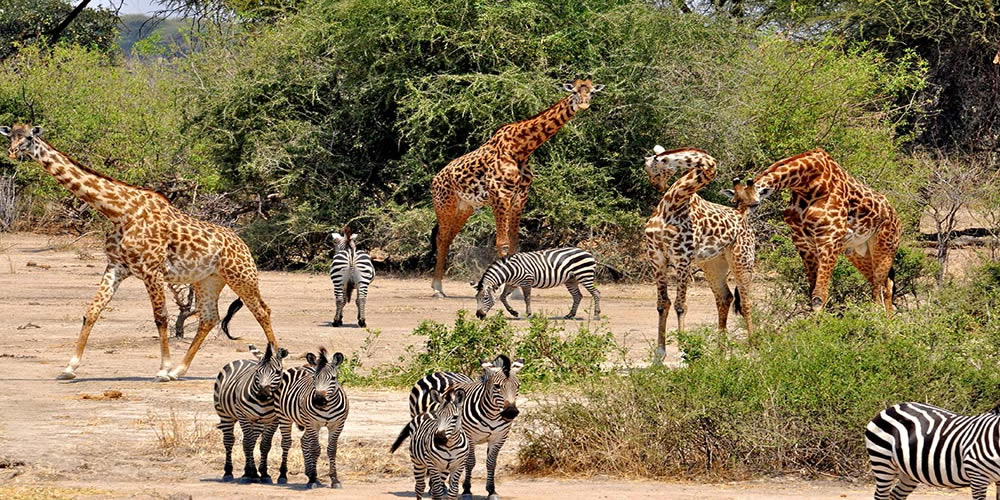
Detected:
[{"left": 519, "top": 306, "right": 1000, "bottom": 478}]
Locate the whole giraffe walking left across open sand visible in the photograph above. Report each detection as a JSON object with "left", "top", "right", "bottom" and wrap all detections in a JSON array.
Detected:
[{"left": 0, "top": 124, "right": 277, "bottom": 382}]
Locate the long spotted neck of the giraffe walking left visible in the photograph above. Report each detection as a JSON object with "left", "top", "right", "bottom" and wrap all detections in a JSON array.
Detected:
[{"left": 32, "top": 140, "right": 142, "bottom": 221}]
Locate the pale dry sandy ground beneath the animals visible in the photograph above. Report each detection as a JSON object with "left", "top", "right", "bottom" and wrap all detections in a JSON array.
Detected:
[{"left": 0, "top": 234, "right": 968, "bottom": 500}]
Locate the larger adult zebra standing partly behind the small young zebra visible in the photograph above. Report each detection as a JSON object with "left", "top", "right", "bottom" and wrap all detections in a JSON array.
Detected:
[{"left": 410, "top": 354, "right": 524, "bottom": 500}]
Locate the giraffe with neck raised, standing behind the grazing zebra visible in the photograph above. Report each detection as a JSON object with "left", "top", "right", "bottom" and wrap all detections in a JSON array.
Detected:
[{"left": 431, "top": 77, "right": 604, "bottom": 297}]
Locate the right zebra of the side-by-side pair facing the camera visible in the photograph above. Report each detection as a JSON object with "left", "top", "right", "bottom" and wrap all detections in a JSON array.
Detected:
[{"left": 277, "top": 348, "right": 348, "bottom": 488}]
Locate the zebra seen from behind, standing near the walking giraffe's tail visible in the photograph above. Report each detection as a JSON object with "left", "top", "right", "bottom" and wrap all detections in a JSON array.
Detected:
[{"left": 330, "top": 227, "right": 375, "bottom": 328}]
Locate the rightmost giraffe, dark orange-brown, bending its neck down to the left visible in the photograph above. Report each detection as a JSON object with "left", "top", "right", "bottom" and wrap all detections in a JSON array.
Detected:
[{"left": 754, "top": 148, "right": 903, "bottom": 314}]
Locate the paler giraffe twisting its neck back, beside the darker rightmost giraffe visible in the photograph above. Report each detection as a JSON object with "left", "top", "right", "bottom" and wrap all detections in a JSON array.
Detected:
[{"left": 645, "top": 146, "right": 759, "bottom": 360}]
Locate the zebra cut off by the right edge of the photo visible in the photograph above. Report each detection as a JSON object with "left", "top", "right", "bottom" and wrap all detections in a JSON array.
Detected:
[{"left": 865, "top": 403, "right": 1000, "bottom": 500}]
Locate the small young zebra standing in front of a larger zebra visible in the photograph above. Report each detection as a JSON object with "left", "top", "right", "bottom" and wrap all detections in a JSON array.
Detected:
[{"left": 389, "top": 388, "right": 470, "bottom": 500}]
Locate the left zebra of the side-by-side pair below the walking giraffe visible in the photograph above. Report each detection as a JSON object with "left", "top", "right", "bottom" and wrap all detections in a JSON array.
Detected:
[{"left": 213, "top": 344, "right": 288, "bottom": 483}]
